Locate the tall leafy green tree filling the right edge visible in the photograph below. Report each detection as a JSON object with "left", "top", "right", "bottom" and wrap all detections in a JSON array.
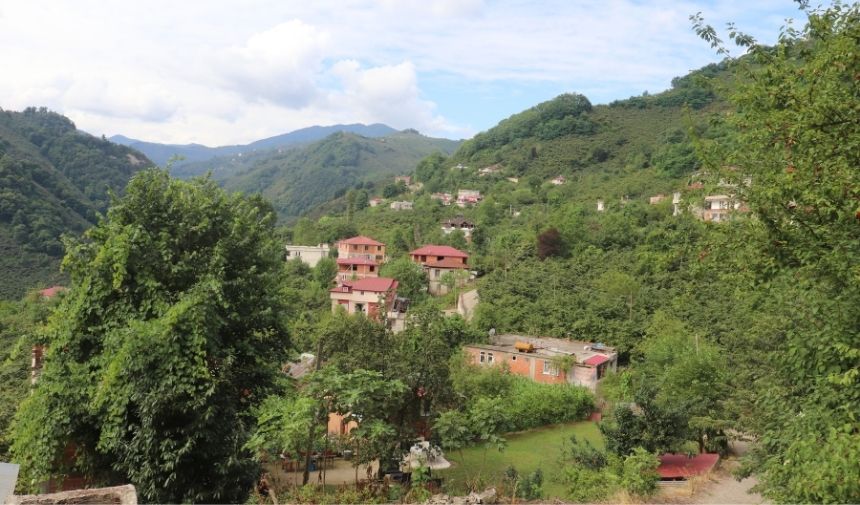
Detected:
[{"left": 694, "top": 2, "right": 860, "bottom": 503}]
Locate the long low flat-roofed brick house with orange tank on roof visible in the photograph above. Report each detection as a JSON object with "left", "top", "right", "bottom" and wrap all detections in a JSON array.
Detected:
[{"left": 464, "top": 334, "right": 618, "bottom": 391}]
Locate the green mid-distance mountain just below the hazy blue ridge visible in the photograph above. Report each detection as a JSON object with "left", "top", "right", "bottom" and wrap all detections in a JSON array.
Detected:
[{"left": 209, "top": 130, "right": 460, "bottom": 219}]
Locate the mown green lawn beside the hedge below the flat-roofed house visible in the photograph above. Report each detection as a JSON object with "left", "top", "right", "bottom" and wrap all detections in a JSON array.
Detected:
[{"left": 433, "top": 421, "right": 603, "bottom": 499}]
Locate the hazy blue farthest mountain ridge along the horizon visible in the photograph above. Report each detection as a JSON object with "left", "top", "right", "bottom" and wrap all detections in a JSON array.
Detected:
[{"left": 109, "top": 123, "right": 397, "bottom": 167}]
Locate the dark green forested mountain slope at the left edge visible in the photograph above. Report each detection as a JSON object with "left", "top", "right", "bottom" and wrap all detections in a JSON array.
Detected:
[{"left": 0, "top": 107, "right": 152, "bottom": 298}]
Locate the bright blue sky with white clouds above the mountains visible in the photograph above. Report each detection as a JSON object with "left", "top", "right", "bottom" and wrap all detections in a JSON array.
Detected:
[{"left": 0, "top": 0, "right": 802, "bottom": 146}]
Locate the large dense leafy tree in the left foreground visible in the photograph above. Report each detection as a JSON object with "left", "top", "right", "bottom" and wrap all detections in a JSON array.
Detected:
[{"left": 12, "top": 170, "right": 289, "bottom": 502}]
